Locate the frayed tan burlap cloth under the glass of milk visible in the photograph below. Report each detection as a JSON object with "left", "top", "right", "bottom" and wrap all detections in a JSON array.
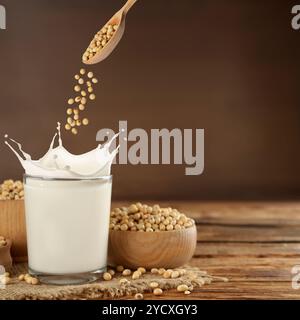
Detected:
[{"left": 0, "top": 264, "right": 227, "bottom": 300}]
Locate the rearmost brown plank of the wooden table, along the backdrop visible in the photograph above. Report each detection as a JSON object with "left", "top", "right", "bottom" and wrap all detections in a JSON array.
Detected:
[{"left": 113, "top": 201, "right": 300, "bottom": 226}]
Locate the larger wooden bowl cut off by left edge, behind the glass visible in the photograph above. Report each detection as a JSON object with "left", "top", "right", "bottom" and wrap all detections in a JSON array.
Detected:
[{"left": 0, "top": 200, "right": 27, "bottom": 261}]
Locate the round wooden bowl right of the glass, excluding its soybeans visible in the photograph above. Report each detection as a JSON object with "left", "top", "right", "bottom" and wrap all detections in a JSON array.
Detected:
[{"left": 108, "top": 226, "right": 197, "bottom": 269}]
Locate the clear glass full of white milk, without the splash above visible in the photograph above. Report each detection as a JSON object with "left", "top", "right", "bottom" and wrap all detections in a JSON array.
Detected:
[{"left": 24, "top": 175, "right": 112, "bottom": 284}]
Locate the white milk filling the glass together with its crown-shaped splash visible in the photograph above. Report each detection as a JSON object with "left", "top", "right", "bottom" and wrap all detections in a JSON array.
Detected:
[{"left": 5, "top": 124, "right": 118, "bottom": 275}]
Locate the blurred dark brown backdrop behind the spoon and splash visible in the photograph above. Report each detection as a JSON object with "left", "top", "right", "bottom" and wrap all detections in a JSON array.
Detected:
[{"left": 0, "top": 0, "right": 300, "bottom": 199}]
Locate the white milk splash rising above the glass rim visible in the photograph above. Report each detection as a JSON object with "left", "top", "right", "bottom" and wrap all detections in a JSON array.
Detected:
[{"left": 5, "top": 122, "right": 119, "bottom": 179}]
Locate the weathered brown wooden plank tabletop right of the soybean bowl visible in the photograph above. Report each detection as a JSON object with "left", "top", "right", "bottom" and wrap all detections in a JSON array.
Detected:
[{"left": 114, "top": 201, "right": 300, "bottom": 299}]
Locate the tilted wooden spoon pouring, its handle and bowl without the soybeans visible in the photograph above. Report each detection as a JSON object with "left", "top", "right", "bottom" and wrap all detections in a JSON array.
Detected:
[{"left": 82, "top": 0, "right": 137, "bottom": 64}]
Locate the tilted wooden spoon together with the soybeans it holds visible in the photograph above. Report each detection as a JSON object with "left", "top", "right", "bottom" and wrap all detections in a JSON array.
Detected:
[{"left": 82, "top": 0, "right": 137, "bottom": 64}]
